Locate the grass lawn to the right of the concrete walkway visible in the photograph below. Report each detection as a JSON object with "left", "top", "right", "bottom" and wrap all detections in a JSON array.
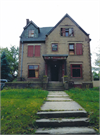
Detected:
[{"left": 65, "top": 88, "right": 99, "bottom": 132}]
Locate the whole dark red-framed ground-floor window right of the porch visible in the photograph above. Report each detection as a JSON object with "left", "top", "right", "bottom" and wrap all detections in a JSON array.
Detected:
[{"left": 71, "top": 64, "right": 82, "bottom": 78}]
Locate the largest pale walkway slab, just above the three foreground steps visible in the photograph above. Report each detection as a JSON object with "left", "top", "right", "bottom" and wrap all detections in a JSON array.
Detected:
[{"left": 41, "top": 101, "right": 84, "bottom": 111}]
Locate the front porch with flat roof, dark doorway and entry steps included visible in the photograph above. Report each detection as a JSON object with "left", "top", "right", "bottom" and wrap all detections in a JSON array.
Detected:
[{"left": 43, "top": 54, "right": 68, "bottom": 90}]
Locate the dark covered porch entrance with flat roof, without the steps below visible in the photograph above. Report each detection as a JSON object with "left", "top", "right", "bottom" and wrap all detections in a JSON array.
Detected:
[{"left": 43, "top": 54, "right": 68, "bottom": 82}]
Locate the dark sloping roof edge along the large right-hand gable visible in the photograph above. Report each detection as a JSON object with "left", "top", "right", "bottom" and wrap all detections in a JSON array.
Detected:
[{"left": 47, "top": 14, "right": 89, "bottom": 36}]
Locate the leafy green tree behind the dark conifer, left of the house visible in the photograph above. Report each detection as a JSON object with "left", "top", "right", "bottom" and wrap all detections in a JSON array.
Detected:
[{"left": 0, "top": 46, "right": 19, "bottom": 77}]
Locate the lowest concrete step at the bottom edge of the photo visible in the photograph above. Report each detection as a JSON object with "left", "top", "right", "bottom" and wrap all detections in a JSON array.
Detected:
[{"left": 35, "top": 127, "right": 96, "bottom": 135}]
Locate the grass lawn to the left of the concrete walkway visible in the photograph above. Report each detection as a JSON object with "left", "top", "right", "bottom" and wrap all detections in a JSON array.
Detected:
[{"left": 1, "top": 88, "right": 48, "bottom": 134}]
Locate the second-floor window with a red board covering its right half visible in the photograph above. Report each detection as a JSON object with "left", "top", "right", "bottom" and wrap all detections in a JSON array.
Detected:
[{"left": 69, "top": 43, "right": 83, "bottom": 55}]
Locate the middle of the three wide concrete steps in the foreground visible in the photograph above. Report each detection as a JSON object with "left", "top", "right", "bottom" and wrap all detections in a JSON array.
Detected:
[{"left": 36, "top": 118, "right": 89, "bottom": 128}]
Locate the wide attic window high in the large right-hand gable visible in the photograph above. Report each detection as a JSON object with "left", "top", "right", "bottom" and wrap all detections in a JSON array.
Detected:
[{"left": 61, "top": 28, "right": 74, "bottom": 37}]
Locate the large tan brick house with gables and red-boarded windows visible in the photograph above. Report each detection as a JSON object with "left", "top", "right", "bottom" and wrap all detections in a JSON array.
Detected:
[{"left": 18, "top": 14, "right": 92, "bottom": 86}]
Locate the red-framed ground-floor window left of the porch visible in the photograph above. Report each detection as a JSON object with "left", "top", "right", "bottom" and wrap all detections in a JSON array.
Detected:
[{"left": 28, "top": 65, "right": 39, "bottom": 78}]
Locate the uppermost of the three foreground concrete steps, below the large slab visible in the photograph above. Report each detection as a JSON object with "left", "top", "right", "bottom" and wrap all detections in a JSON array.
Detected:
[{"left": 37, "top": 111, "right": 87, "bottom": 118}]
